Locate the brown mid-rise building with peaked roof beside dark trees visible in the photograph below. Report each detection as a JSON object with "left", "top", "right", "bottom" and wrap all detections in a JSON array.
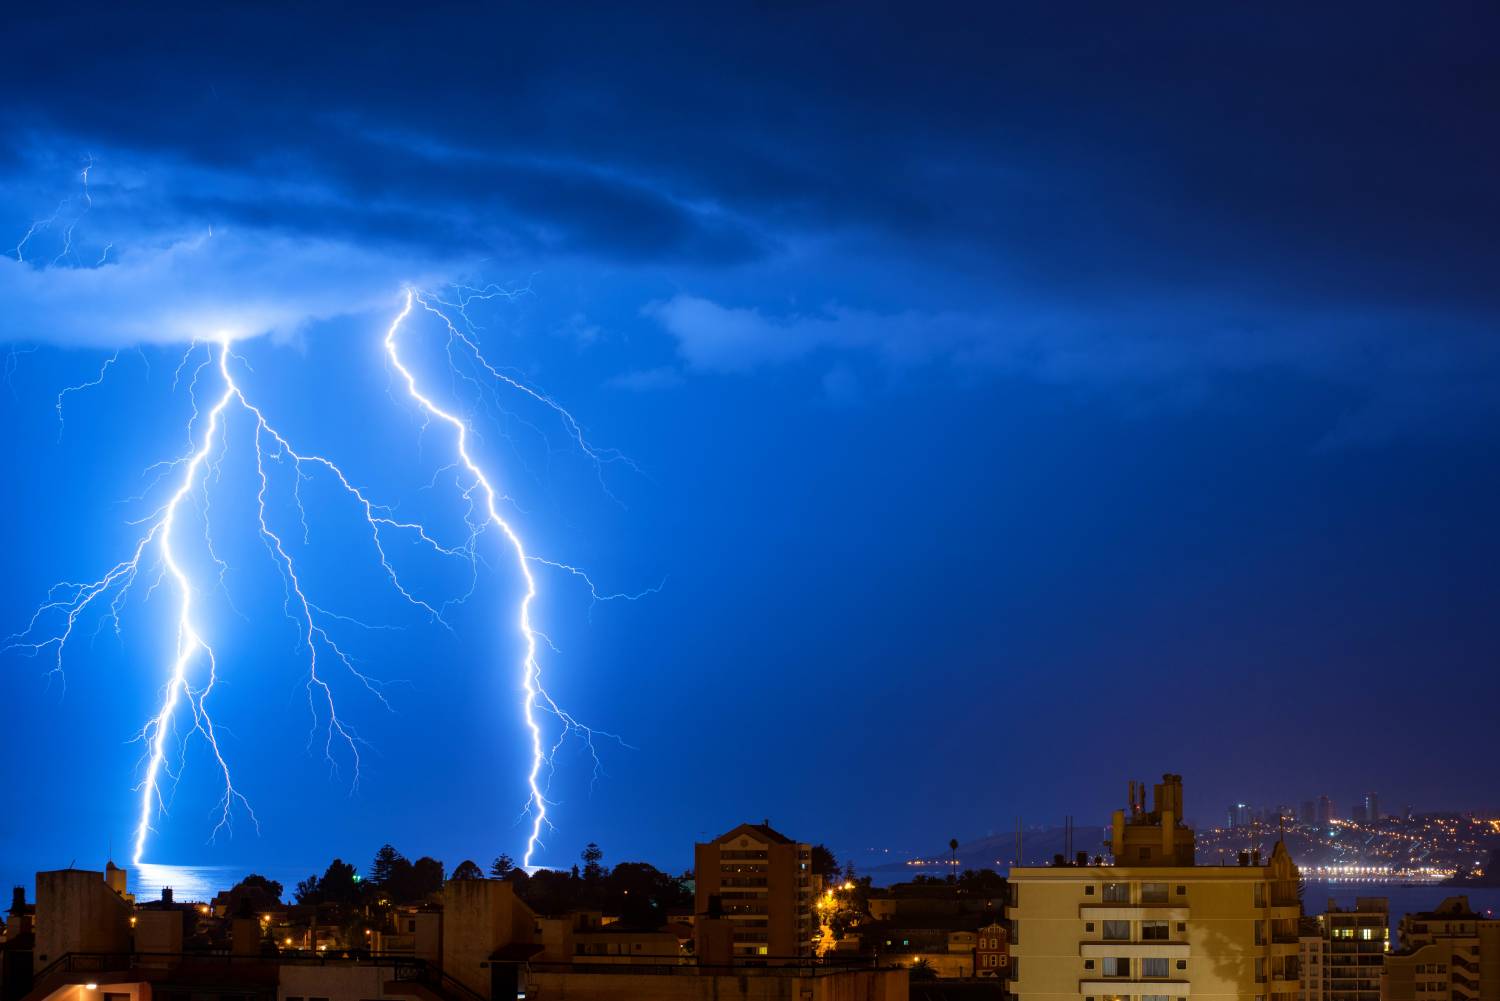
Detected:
[{"left": 693, "top": 824, "right": 821, "bottom": 962}]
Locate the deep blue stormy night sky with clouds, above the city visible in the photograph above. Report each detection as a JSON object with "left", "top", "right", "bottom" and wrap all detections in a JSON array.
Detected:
[{"left": 0, "top": 3, "right": 1500, "bottom": 878}]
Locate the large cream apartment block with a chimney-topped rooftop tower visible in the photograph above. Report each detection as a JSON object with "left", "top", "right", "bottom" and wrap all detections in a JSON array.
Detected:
[{"left": 1008, "top": 774, "right": 1301, "bottom": 1001}]
